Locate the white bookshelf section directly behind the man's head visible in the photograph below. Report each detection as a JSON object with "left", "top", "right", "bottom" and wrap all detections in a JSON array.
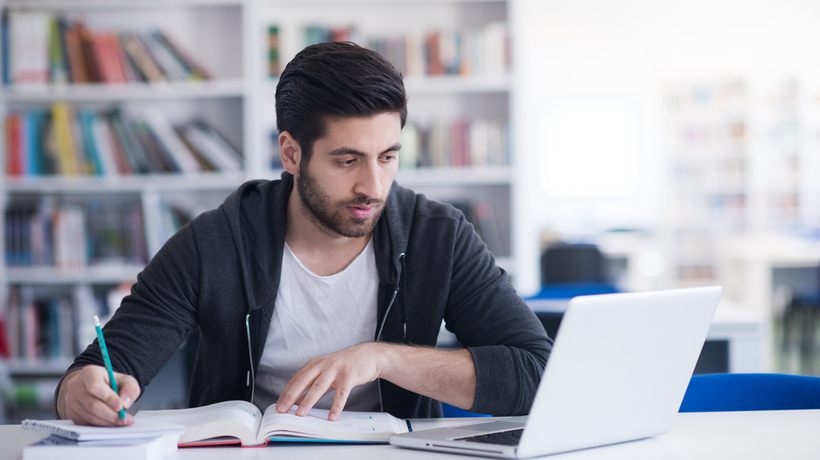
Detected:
[{"left": 254, "top": 0, "right": 516, "bottom": 262}]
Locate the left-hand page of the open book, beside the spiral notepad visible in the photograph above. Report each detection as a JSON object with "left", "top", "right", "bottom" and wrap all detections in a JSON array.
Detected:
[{"left": 136, "top": 401, "right": 262, "bottom": 445}]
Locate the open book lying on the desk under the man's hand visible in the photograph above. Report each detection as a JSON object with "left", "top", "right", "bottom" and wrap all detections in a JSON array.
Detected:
[{"left": 136, "top": 401, "right": 412, "bottom": 447}]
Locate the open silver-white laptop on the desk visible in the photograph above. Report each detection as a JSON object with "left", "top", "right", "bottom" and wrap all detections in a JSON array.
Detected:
[{"left": 390, "top": 286, "right": 721, "bottom": 458}]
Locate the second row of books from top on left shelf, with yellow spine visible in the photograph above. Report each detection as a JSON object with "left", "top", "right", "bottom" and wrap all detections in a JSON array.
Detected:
[{"left": 5, "top": 102, "right": 242, "bottom": 176}]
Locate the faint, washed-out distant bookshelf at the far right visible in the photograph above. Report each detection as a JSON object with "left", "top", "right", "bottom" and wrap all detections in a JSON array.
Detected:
[{"left": 666, "top": 74, "right": 820, "bottom": 285}]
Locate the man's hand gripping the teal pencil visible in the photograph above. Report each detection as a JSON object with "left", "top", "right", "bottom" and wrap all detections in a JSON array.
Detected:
[{"left": 57, "top": 365, "right": 140, "bottom": 426}]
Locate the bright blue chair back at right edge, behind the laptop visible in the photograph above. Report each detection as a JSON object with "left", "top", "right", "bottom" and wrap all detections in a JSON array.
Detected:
[{"left": 680, "top": 374, "right": 820, "bottom": 412}]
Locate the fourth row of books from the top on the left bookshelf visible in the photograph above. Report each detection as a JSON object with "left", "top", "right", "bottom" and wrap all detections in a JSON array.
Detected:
[{"left": 0, "top": 285, "right": 119, "bottom": 361}]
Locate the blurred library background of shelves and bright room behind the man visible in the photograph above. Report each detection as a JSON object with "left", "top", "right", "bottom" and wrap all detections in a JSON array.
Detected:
[{"left": 0, "top": 0, "right": 820, "bottom": 423}]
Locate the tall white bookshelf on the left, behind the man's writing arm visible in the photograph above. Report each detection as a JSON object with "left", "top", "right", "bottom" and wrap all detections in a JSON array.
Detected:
[{"left": 0, "top": 0, "right": 250, "bottom": 420}]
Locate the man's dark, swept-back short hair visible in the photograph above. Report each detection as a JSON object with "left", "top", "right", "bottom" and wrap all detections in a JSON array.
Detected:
[{"left": 276, "top": 42, "right": 407, "bottom": 161}]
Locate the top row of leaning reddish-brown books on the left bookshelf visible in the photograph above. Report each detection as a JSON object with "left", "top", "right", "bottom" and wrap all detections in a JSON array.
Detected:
[{"left": 3, "top": 10, "right": 211, "bottom": 85}]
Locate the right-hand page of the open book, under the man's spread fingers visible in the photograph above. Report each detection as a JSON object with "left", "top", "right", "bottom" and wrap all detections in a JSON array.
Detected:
[{"left": 259, "top": 404, "right": 408, "bottom": 442}]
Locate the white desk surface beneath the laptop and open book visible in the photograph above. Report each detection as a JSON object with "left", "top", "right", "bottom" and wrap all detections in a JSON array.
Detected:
[{"left": 0, "top": 410, "right": 820, "bottom": 460}]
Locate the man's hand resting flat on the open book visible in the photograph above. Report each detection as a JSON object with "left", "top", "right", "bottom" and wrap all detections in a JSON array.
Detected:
[{"left": 276, "top": 342, "right": 384, "bottom": 420}]
